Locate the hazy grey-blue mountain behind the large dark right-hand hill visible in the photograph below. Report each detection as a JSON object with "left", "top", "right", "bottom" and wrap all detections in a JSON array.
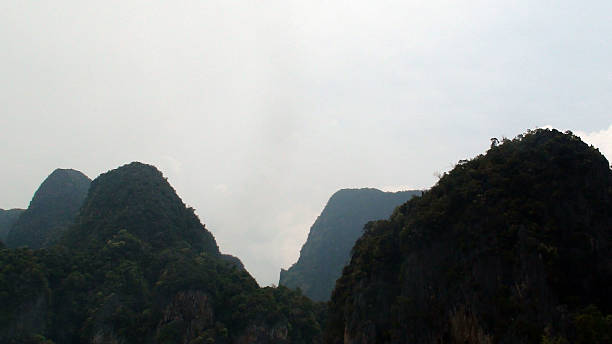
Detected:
[{"left": 279, "top": 189, "right": 421, "bottom": 301}]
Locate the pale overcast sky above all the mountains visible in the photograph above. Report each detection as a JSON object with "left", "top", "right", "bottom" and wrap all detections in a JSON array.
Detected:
[{"left": 0, "top": 0, "right": 612, "bottom": 285}]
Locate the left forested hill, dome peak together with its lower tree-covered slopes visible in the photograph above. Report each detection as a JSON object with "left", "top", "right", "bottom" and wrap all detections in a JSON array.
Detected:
[{"left": 0, "top": 163, "right": 325, "bottom": 343}]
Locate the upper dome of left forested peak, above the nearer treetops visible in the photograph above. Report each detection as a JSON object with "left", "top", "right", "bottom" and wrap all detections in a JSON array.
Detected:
[{"left": 65, "top": 162, "right": 219, "bottom": 255}]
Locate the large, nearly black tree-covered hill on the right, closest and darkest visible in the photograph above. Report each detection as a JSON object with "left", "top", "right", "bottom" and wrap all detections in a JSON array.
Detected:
[{"left": 326, "top": 130, "right": 612, "bottom": 343}]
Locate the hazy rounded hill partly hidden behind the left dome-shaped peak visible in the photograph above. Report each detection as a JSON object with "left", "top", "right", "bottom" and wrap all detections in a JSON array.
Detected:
[{"left": 6, "top": 169, "right": 91, "bottom": 248}]
